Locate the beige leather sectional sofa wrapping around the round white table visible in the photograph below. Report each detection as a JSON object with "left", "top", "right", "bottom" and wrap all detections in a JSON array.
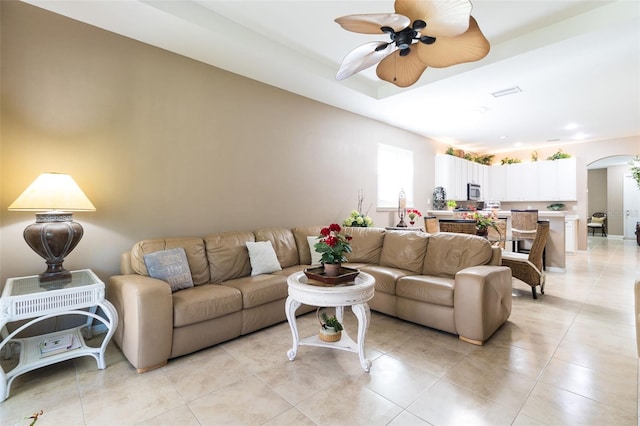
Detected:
[{"left": 107, "top": 226, "right": 511, "bottom": 372}]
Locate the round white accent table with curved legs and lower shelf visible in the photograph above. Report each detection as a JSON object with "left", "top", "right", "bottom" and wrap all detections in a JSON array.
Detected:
[{"left": 285, "top": 272, "right": 376, "bottom": 373}]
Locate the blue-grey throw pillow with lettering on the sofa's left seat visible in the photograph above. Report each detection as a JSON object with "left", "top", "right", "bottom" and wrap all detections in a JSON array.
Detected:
[{"left": 144, "top": 247, "right": 193, "bottom": 292}]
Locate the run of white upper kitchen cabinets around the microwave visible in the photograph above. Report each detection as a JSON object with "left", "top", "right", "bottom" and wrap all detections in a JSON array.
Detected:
[{"left": 435, "top": 155, "right": 577, "bottom": 201}]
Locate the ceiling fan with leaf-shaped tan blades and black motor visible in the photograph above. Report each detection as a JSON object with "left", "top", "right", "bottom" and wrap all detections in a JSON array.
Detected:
[{"left": 335, "top": 0, "right": 489, "bottom": 87}]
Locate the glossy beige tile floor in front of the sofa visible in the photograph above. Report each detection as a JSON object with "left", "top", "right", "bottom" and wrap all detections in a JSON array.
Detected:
[{"left": 0, "top": 237, "right": 640, "bottom": 426}]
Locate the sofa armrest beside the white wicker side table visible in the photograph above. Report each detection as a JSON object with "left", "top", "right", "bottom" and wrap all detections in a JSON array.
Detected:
[{"left": 107, "top": 274, "right": 173, "bottom": 373}]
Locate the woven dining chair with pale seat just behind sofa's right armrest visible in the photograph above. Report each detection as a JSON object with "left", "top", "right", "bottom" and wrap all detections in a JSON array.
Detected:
[{"left": 502, "top": 221, "right": 549, "bottom": 299}]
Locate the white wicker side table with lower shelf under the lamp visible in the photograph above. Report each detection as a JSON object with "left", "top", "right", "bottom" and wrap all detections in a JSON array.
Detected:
[{"left": 0, "top": 269, "right": 118, "bottom": 402}]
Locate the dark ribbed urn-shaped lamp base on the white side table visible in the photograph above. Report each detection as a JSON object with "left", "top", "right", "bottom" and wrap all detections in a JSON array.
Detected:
[{"left": 23, "top": 211, "right": 84, "bottom": 284}]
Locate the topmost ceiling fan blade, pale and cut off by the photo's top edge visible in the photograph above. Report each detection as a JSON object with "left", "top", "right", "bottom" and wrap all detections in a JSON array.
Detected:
[{"left": 395, "top": 0, "right": 471, "bottom": 37}]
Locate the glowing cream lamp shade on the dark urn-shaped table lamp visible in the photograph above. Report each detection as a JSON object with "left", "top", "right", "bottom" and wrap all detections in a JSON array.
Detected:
[{"left": 9, "top": 173, "right": 96, "bottom": 211}]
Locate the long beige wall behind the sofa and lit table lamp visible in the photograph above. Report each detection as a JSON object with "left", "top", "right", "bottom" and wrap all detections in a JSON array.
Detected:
[{"left": 0, "top": 2, "right": 437, "bottom": 282}]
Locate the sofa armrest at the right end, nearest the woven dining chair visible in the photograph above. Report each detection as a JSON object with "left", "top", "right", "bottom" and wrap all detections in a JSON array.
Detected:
[{"left": 453, "top": 265, "right": 512, "bottom": 345}]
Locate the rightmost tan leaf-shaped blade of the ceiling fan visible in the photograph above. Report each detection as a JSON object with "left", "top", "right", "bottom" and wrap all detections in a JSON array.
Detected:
[{"left": 415, "top": 17, "right": 490, "bottom": 68}]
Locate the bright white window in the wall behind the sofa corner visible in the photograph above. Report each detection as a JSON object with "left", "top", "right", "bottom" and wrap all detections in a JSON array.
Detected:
[{"left": 378, "top": 143, "right": 413, "bottom": 209}]
